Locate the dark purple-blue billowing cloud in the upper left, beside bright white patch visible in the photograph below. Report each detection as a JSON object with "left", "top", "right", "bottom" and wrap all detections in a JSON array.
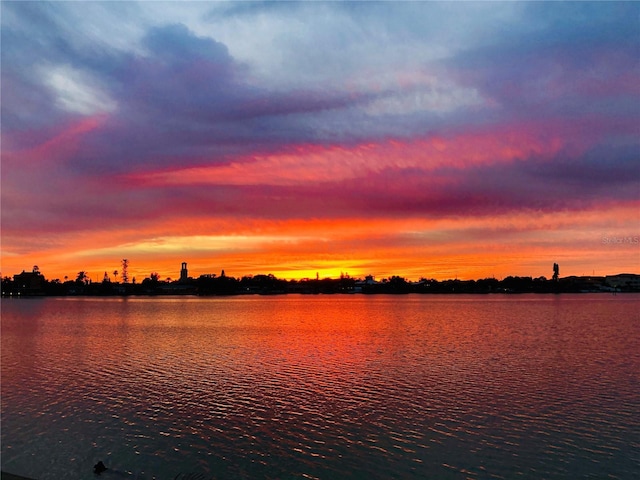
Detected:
[{"left": 48, "top": 25, "right": 396, "bottom": 175}]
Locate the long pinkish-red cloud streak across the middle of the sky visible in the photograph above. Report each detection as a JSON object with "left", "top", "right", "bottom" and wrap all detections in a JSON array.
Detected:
[{"left": 126, "top": 121, "right": 586, "bottom": 190}]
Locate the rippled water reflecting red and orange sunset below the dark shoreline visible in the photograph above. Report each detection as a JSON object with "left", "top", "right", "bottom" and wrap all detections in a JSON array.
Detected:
[{"left": 1, "top": 294, "right": 640, "bottom": 480}]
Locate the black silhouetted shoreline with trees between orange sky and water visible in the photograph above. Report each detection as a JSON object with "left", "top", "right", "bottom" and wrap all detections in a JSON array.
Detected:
[{"left": 2, "top": 268, "right": 640, "bottom": 297}]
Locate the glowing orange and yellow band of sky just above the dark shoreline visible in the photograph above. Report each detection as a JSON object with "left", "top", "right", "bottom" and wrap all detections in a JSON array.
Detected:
[{"left": 2, "top": 204, "right": 640, "bottom": 281}]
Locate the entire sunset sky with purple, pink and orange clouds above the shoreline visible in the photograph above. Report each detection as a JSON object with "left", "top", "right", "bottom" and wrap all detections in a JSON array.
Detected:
[{"left": 0, "top": 1, "right": 640, "bottom": 281}]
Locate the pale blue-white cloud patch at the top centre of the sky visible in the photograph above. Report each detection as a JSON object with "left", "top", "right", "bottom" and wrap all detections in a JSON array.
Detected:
[{"left": 208, "top": 2, "right": 522, "bottom": 88}]
